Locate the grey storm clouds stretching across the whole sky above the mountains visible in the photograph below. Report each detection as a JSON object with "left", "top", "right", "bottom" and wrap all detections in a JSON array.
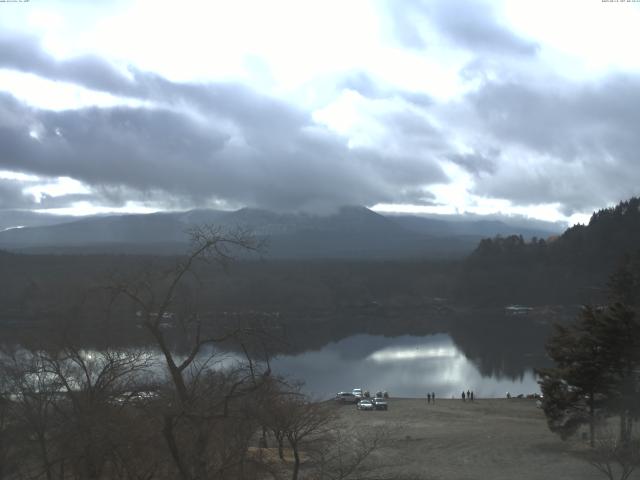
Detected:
[{"left": 0, "top": 28, "right": 640, "bottom": 218}]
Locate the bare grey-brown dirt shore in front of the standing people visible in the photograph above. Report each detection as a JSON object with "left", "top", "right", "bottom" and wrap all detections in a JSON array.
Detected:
[{"left": 335, "top": 399, "right": 640, "bottom": 480}]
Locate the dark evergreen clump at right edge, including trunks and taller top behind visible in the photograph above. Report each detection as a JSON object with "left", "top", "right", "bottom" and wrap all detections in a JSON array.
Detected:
[{"left": 538, "top": 260, "right": 640, "bottom": 479}]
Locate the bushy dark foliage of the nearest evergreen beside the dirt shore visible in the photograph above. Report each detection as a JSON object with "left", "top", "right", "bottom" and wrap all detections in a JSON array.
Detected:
[{"left": 538, "top": 303, "right": 640, "bottom": 446}]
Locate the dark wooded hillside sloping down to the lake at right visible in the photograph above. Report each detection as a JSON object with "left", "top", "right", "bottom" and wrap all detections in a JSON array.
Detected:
[{"left": 456, "top": 198, "right": 640, "bottom": 304}]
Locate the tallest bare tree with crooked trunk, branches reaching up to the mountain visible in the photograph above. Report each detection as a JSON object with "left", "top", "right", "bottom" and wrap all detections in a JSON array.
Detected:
[{"left": 111, "top": 227, "right": 278, "bottom": 480}]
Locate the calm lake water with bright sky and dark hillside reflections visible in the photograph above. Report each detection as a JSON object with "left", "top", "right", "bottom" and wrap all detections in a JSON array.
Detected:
[{"left": 3, "top": 312, "right": 549, "bottom": 399}]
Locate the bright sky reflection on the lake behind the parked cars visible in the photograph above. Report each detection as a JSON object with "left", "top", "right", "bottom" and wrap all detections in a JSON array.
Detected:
[{"left": 272, "top": 334, "right": 539, "bottom": 398}]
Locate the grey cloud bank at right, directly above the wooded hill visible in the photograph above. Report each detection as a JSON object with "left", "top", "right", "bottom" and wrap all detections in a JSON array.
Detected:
[{"left": 467, "top": 76, "right": 640, "bottom": 213}]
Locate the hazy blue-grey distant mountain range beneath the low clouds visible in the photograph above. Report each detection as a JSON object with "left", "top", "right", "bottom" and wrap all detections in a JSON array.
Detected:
[{"left": 0, "top": 207, "right": 560, "bottom": 259}]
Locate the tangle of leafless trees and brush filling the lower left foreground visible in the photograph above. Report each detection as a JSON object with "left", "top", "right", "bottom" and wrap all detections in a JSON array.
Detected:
[{"left": 0, "top": 228, "right": 378, "bottom": 480}]
